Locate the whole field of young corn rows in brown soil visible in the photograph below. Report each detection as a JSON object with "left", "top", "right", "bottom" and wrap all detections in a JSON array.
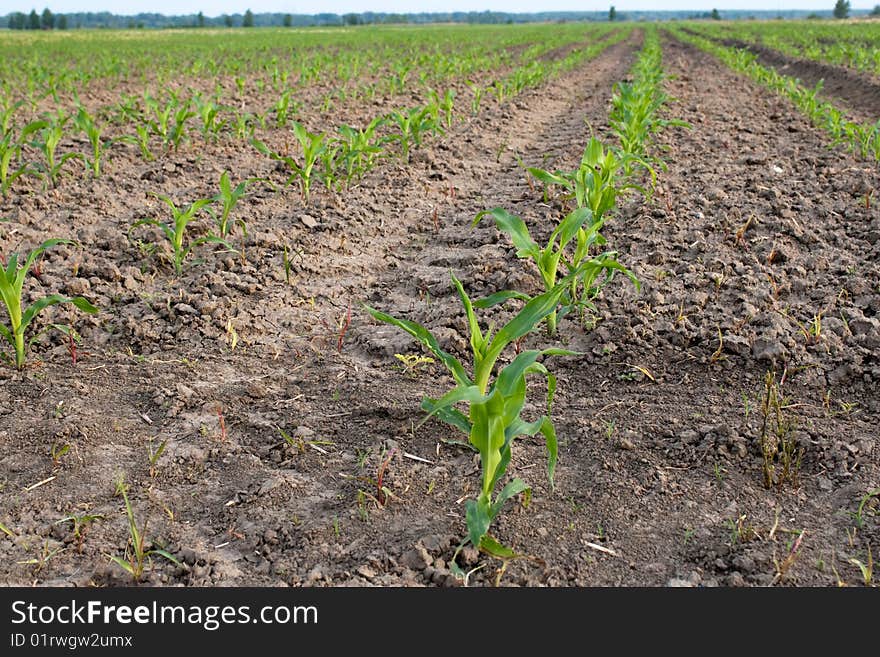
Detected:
[{"left": 0, "top": 21, "right": 880, "bottom": 586}]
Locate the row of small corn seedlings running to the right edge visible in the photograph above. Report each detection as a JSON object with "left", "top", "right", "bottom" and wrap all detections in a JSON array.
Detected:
[{"left": 669, "top": 28, "right": 880, "bottom": 160}]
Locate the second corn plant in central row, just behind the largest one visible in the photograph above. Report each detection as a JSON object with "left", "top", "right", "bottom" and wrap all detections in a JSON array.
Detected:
[{"left": 474, "top": 208, "right": 639, "bottom": 336}]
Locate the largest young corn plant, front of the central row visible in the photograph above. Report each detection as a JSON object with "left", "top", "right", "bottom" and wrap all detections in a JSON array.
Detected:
[{"left": 366, "top": 274, "right": 573, "bottom": 558}]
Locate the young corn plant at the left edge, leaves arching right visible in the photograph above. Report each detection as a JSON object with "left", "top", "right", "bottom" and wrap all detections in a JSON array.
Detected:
[{"left": 0, "top": 239, "right": 98, "bottom": 369}]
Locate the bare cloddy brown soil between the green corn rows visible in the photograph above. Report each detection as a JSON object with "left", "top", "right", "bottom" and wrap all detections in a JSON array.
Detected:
[{"left": 0, "top": 30, "right": 880, "bottom": 586}]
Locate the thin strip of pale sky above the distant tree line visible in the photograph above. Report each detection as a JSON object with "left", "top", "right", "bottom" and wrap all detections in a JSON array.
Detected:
[{"left": 0, "top": 0, "right": 880, "bottom": 16}]
